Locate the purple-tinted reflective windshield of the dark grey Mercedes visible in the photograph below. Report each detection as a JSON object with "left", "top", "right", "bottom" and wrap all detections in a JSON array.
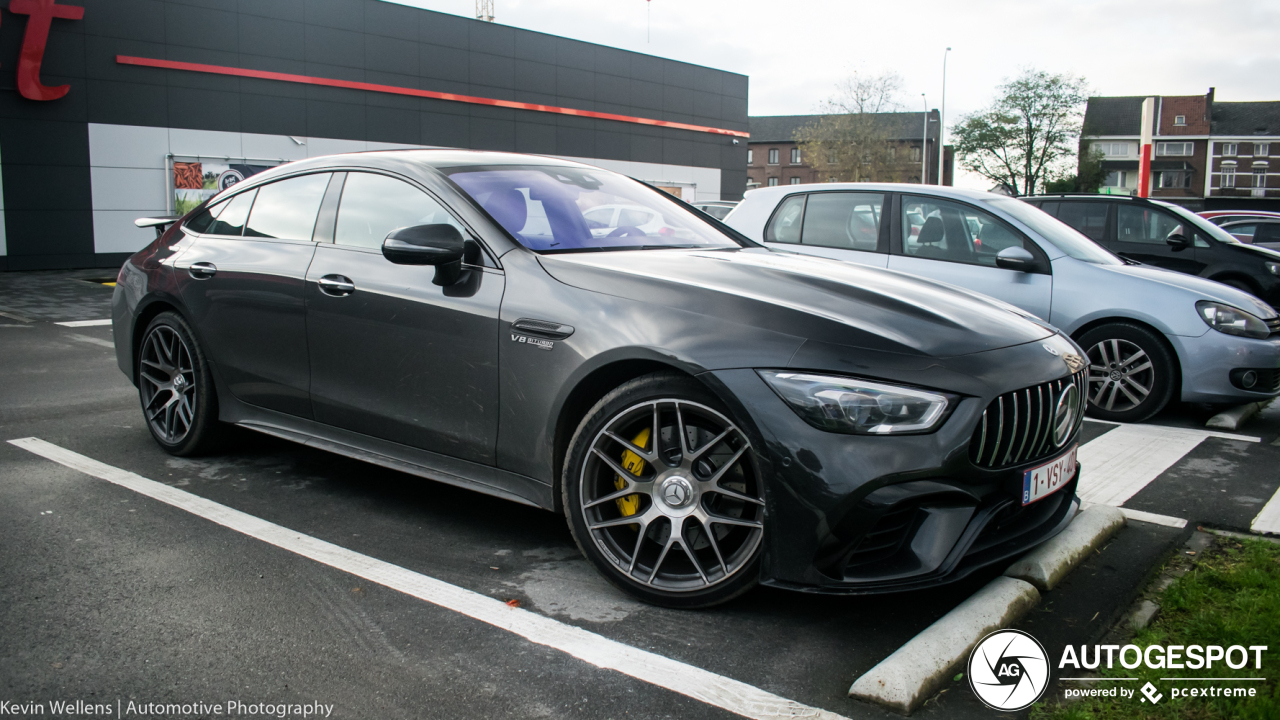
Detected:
[{"left": 442, "top": 165, "right": 740, "bottom": 252}]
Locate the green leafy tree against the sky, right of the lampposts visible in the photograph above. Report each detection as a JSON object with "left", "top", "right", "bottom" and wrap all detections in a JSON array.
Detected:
[{"left": 951, "top": 69, "right": 1088, "bottom": 195}]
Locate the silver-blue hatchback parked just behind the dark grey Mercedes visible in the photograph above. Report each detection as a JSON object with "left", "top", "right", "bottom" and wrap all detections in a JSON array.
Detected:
[{"left": 724, "top": 183, "right": 1280, "bottom": 421}]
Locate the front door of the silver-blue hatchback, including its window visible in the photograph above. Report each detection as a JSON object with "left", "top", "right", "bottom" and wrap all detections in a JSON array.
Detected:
[{"left": 888, "top": 195, "right": 1053, "bottom": 320}]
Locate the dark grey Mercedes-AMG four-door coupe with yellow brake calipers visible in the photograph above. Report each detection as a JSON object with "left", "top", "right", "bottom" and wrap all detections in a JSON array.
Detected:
[{"left": 113, "top": 150, "right": 1084, "bottom": 607}]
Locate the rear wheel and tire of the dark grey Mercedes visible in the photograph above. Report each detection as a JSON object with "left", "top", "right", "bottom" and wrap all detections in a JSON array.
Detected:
[{"left": 136, "top": 311, "right": 224, "bottom": 456}]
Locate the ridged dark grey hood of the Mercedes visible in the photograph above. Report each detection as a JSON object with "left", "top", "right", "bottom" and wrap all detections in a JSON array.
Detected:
[{"left": 539, "top": 249, "right": 1055, "bottom": 357}]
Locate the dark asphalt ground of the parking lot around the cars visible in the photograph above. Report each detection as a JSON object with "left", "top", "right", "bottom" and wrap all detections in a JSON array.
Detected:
[{"left": 0, "top": 272, "right": 1280, "bottom": 717}]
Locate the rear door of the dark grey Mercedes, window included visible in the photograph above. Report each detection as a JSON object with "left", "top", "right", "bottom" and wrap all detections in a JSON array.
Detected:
[{"left": 174, "top": 173, "right": 330, "bottom": 418}]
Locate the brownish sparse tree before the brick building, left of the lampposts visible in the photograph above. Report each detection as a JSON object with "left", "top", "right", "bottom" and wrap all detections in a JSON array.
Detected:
[{"left": 795, "top": 72, "right": 916, "bottom": 182}]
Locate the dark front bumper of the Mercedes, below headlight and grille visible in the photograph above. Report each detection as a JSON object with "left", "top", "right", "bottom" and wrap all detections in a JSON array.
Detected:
[{"left": 712, "top": 335, "right": 1084, "bottom": 594}]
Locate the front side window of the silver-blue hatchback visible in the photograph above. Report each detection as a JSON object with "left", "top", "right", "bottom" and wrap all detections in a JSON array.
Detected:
[{"left": 902, "top": 196, "right": 1039, "bottom": 268}]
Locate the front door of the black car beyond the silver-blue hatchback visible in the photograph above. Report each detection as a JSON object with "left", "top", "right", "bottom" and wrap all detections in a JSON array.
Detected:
[{"left": 1111, "top": 202, "right": 1212, "bottom": 275}]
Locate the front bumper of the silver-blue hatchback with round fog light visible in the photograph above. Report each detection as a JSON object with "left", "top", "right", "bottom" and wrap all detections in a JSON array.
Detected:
[{"left": 1166, "top": 328, "right": 1280, "bottom": 402}]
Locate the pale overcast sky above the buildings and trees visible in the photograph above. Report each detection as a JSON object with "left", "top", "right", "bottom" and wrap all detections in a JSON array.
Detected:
[{"left": 398, "top": 0, "right": 1280, "bottom": 184}]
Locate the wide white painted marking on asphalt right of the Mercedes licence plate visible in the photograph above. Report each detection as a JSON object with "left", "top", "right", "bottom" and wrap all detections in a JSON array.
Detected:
[{"left": 1076, "top": 424, "right": 1262, "bottom": 507}]
